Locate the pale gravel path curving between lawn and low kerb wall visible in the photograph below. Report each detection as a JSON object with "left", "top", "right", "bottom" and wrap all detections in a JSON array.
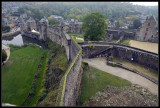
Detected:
[{"left": 83, "top": 58, "right": 158, "bottom": 95}]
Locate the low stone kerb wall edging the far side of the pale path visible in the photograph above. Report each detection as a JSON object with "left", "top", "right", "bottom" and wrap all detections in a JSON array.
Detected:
[{"left": 107, "top": 61, "right": 158, "bottom": 85}]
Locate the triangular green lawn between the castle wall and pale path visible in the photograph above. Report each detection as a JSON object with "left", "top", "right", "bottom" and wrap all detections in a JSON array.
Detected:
[{"left": 80, "top": 66, "right": 131, "bottom": 104}]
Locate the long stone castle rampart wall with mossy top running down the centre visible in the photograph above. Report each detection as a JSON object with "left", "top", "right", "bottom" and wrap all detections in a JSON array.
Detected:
[{"left": 44, "top": 25, "right": 83, "bottom": 106}]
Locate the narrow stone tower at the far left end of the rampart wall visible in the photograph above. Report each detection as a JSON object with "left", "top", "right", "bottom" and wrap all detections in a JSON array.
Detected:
[{"left": 39, "top": 17, "right": 48, "bottom": 41}]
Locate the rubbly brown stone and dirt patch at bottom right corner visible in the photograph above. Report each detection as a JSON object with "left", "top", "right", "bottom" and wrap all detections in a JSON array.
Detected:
[{"left": 83, "top": 84, "right": 158, "bottom": 106}]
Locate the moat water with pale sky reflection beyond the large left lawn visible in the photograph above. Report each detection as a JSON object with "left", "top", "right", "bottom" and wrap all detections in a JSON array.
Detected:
[{"left": 2, "top": 34, "right": 47, "bottom": 49}]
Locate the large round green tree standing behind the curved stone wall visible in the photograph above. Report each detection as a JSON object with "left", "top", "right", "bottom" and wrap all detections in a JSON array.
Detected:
[{"left": 82, "top": 12, "right": 108, "bottom": 41}]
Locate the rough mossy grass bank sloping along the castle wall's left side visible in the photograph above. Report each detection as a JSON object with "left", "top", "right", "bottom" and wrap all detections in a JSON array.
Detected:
[{"left": 36, "top": 39, "right": 69, "bottom": 106}]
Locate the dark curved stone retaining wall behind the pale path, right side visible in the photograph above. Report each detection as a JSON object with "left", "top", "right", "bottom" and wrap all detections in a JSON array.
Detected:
[{"left": 79, "top": 42, "right": 159, "bottom": 71}]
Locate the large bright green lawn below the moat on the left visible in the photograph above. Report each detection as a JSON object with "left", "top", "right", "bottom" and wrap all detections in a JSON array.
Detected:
[{"left": 1, "top": 46, "right": 47, "bottom": 105}]
